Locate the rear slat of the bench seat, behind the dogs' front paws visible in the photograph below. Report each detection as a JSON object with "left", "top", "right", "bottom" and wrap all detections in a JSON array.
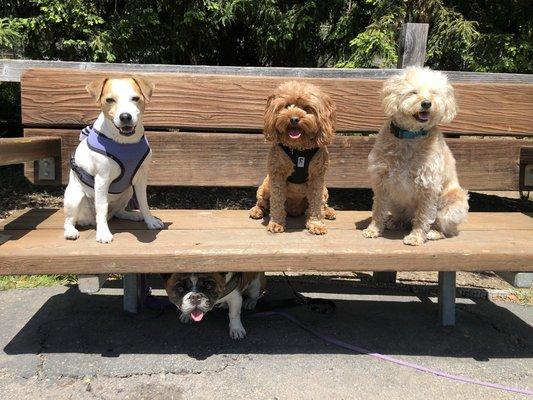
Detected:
[{"left": 0, "top": 208, "right": 533, "bottom": 232}]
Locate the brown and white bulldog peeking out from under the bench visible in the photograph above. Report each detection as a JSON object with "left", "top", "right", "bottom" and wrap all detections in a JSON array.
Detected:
[{"left": 162, "top": 272, "right": 266, "bottom": 339}]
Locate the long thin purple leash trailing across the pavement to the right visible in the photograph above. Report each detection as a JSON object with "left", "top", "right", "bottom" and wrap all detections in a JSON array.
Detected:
[{"left": 250, "top": 311, "right": 533, "bottom": 396}]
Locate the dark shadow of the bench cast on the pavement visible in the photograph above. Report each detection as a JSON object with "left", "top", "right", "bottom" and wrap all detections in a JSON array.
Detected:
[{"left": 4, "top": 276, "right": 533, "bottom": 361}]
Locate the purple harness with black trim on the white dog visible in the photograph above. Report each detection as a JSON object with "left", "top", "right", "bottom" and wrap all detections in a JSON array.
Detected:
[{"left": 70, "top": 125, "right": 150, "bottom": 194}]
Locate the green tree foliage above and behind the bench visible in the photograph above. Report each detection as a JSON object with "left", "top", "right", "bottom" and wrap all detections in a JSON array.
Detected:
[{"left": 0, "top": 0, "right": 533, "bottom": 72}]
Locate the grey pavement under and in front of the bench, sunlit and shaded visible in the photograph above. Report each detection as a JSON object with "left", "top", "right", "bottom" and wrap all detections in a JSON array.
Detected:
[{"left": 0, "top": 277, "right": 533, "bottom": 400}]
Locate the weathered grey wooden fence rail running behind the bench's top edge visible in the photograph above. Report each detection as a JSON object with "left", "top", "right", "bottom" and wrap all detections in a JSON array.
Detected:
[{"left": 0, "top": 59, "right": 533, "bottom": 83}]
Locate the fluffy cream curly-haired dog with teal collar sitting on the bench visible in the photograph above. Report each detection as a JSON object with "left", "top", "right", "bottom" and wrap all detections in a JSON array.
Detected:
[{"left": 363, "top": 67, "right": 468, "bottom": 246}]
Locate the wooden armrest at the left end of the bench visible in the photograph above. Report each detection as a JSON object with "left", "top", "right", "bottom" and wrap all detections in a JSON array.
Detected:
[{"left": 0, "top": 136, "right": 61, "bottom": 165}]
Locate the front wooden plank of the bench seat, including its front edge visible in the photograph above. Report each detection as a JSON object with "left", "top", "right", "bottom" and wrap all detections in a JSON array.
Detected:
[{"left": 0, "top": 228, "right": 533, "bottom": 274}]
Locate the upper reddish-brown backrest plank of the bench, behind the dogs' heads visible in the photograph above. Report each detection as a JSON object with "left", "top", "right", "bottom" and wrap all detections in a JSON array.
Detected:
[{"left": 22, "top": 69, "right": 533, "bottom": 135}]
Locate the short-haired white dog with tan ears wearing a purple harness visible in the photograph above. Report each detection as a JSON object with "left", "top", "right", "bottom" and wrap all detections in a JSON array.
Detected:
[{"left": 64, "top": 77, "right": 163, "bottom": 243}]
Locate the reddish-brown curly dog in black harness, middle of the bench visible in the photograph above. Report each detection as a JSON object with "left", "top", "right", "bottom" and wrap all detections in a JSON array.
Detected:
[{"left": 250, "top": 81, "right": 335, "bottom": 235}]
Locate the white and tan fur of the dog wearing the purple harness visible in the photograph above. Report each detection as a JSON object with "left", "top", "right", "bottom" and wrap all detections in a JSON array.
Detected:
[{"left": 64, "top": 78, "right": 163, "bottom": 243}]
